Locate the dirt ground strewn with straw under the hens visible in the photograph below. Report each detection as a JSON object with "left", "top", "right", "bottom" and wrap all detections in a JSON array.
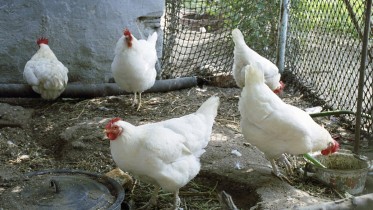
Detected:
[{"left": 0, "top": 86, "right": 366, "bottom": 209}]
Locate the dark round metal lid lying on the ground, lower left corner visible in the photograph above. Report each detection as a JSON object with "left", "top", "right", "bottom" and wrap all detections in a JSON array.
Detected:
[{"left": 2, "top": 170, "right": 124, "bottom": 210}]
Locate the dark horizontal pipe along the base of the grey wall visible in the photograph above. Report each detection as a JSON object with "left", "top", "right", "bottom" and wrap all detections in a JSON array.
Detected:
[{"left": 0, "top": 77, "right": 198, "bottom": 98}]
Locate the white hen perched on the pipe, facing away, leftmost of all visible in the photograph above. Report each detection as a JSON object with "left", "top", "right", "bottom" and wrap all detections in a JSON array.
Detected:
[{"left": 23, "top": 38, "right": 69, "bottom": 100}]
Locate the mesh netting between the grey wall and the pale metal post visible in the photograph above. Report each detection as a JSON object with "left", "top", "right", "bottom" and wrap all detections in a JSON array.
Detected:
[{"left": 162, "top": 0, "right": 279, "bottom": 86}]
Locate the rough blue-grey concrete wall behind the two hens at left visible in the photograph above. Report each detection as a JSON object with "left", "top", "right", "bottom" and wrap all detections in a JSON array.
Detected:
[{"left": 0, "top": 0, "right": 165, "bottom": 83}]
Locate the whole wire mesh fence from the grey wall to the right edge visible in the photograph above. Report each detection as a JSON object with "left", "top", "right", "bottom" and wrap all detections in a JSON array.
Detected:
[{"left": 161, "top": 0, "right": 373, "bottom": 151}]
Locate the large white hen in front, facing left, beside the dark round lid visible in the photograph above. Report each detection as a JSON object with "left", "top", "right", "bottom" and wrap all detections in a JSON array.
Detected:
[{"left": 105, "top": 96, "right": 219, "bottom": 209}]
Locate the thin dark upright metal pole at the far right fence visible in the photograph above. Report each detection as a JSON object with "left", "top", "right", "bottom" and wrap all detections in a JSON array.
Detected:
[{"left": 354, "top": 0, "right": 372, "bottom": 154}]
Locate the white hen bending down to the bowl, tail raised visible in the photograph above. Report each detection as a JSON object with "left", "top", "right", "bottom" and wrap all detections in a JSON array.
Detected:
[{"left": 238, "top": 66, "right": 339, "bottom": 178}]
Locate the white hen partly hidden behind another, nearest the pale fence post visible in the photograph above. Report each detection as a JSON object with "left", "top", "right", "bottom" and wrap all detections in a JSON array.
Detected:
[{"left": 232, "top": 28, "right": 284, "bottom": 93}]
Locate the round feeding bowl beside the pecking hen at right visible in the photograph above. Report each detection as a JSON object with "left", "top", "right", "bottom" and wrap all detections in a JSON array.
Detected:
[{"left": 315, "top": 151, "right": 369, "bottom": 195}]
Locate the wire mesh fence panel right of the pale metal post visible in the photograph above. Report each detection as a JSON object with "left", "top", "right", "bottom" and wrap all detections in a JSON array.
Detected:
[{"left": 286, "top": 0, "right": 373, "bottom": 137}]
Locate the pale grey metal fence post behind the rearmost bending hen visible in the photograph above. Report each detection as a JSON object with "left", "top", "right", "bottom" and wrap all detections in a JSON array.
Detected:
[{"left": 277, "top": 0, "right": 289, "bottom": 74}]
